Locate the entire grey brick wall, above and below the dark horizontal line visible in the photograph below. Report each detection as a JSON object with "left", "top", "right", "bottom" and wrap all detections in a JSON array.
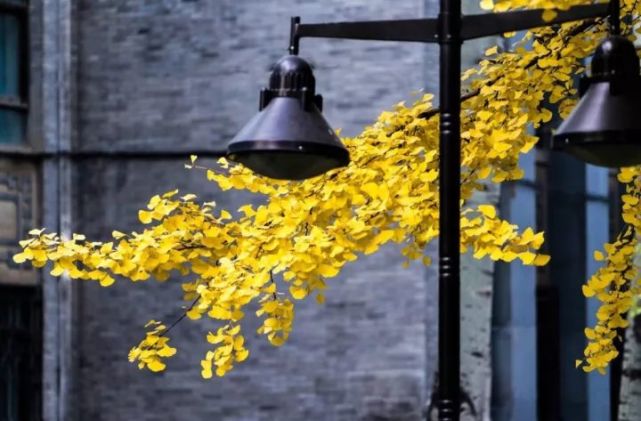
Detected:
[{"left": 31, "top": 0, "right": 500, "bottom": 421}]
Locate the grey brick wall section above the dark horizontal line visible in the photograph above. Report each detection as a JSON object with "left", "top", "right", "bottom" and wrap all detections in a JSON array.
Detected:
[{"left": 78, "top": 0, "right": 436, "bottom": 149}]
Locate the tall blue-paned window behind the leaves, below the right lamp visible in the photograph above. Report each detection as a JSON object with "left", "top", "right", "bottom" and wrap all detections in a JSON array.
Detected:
[{"left": 492, "top": 128, "right": 620, "bottom": 421}]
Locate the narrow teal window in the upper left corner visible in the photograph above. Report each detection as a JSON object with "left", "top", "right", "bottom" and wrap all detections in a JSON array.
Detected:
[{"left": 0, "top": 0, "right": 29, "bottom": 144}]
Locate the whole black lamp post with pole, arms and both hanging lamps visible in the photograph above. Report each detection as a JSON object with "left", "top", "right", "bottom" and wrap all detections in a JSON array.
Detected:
[{"left": 228, "top": 0, "right": 641, "bottom": 421}]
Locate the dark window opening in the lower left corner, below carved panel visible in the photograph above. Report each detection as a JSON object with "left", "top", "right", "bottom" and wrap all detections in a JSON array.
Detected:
[{"left": 0, "top": 286, "right": 41, "bottom": 421}]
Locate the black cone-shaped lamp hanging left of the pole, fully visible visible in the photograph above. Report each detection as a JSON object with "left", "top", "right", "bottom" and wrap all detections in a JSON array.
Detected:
[{"left": 227, "top": 55, "right": 349, "bottom": 180}]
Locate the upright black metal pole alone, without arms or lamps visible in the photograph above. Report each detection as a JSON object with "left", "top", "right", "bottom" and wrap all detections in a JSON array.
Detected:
[{"left": 438, "top": 0, "right": 462, "bottom": 421}]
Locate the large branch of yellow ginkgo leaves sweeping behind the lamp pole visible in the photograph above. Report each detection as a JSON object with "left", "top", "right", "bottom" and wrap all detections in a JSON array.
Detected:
[{"left": 16, "top": 0, "right": 640, "bottom": 377}]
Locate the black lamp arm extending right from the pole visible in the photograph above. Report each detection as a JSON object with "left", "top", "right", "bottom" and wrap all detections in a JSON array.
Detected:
[{"left": 461, "top": 3, "right": 610, "bottom": 40}]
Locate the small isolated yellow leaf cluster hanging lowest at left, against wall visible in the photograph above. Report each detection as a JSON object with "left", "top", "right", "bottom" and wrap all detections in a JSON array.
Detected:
[{"left": 129, "top": 320, "right": 176, "bottom": 372}]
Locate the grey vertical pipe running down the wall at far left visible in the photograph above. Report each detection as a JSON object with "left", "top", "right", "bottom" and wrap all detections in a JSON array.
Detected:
[{"left": 41, "top": 0, "right": 76, "bottom": 421}]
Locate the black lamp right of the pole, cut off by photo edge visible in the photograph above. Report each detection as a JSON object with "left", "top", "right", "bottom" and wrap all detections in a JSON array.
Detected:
[{"left": 552, "top": 36, "right": 641, "bottom": 167}]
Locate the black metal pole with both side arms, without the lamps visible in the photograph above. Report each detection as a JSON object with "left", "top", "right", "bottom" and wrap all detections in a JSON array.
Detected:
[{"left": 289, "top": 5, "right": 620, "bottom": 421}]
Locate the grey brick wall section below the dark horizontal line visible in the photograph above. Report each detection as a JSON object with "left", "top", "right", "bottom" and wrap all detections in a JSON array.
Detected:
[{"left": 77, "top": 162, "right": 426, "bottom": 420}]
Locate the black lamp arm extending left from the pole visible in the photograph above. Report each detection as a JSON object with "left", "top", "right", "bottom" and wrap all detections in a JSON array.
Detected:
[{"left": 292, "top": 19, "right": 438, "bottom": 42}]
